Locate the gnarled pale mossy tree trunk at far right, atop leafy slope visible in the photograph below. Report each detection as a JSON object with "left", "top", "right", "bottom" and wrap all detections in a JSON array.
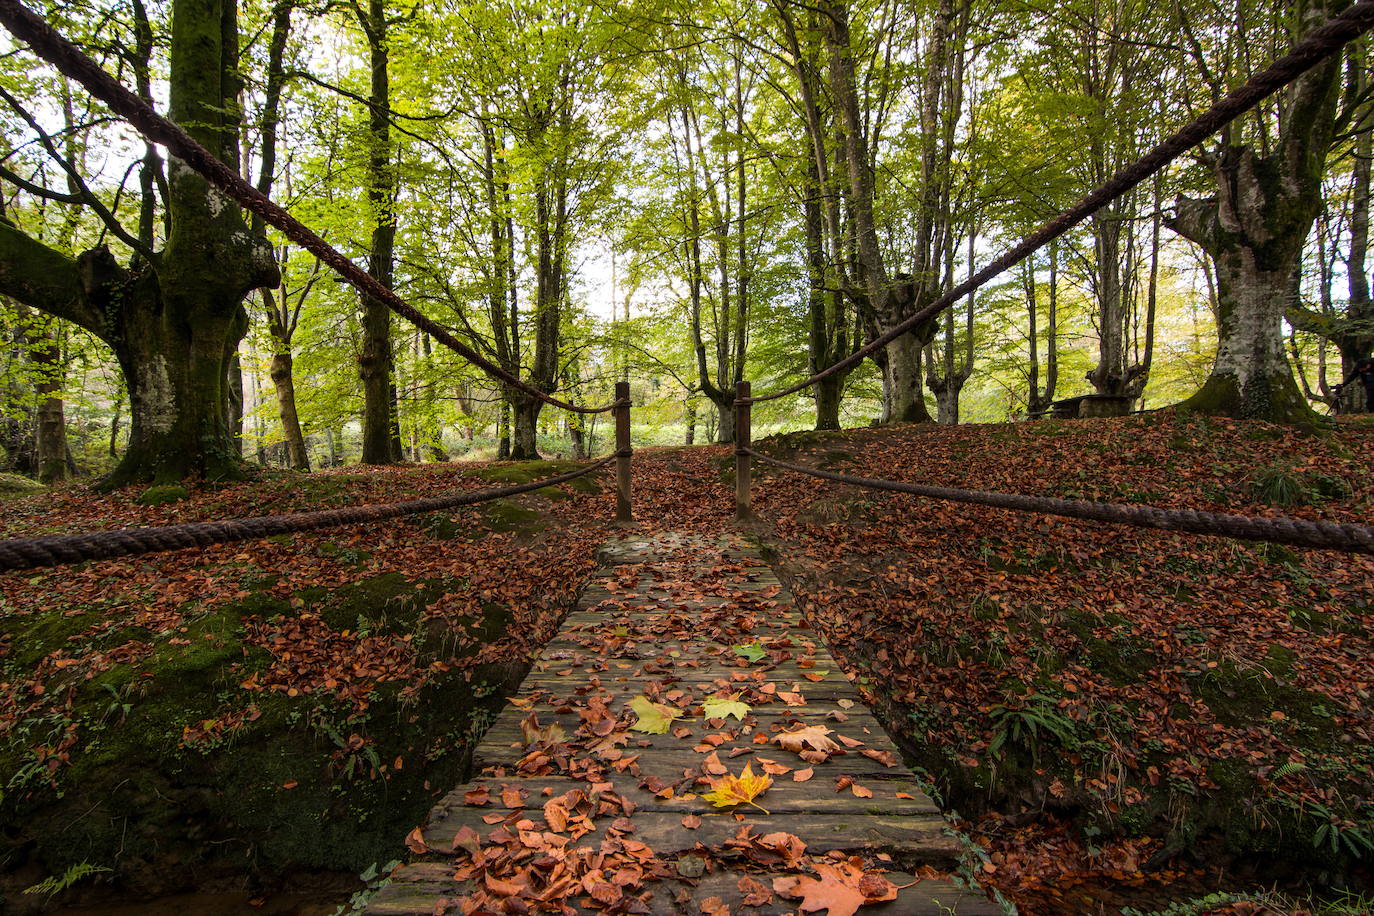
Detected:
[{"left": 1167, "top": 1, "right": 1341, "bottom": 423}]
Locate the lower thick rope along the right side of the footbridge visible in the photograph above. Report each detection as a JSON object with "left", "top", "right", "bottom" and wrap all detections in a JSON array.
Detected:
[{"left": 739, "top": 448, "right": 1374, "bottom": 553}]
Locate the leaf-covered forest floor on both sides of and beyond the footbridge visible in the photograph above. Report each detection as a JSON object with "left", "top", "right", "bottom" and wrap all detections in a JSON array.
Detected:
[{"left": 0, "top": 412, "right": 1374, "bottom": 916}]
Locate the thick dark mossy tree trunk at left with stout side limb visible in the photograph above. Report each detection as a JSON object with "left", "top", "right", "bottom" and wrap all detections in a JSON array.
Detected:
[{"left": 0, "top": 0, "right": 279, "bottom": 486}]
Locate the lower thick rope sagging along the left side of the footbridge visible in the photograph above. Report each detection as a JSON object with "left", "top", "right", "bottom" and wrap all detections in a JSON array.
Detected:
[{"left": 0, "top": 455, "right": 616, "bottom": 570}]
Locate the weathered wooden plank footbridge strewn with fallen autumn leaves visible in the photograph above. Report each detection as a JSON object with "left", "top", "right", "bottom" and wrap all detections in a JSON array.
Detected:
[{"left": 367, "top": 534, "right": 1002, "bottom": 916}]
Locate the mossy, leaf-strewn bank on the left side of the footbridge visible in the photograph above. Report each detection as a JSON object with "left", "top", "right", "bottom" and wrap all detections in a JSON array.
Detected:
[{"left": 0, "top": 466, "right": 609, "bottom": 912}]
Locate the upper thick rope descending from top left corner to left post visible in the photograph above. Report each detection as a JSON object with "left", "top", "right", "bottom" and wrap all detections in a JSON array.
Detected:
[{"left": 0, "top": 0, "right": 616, "bottom": 413}]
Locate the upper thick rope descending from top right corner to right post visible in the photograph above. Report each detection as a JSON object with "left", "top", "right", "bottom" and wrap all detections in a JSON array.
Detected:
[{"left": 747, "top": 0, "right": 1374, "bottom": 404}]
